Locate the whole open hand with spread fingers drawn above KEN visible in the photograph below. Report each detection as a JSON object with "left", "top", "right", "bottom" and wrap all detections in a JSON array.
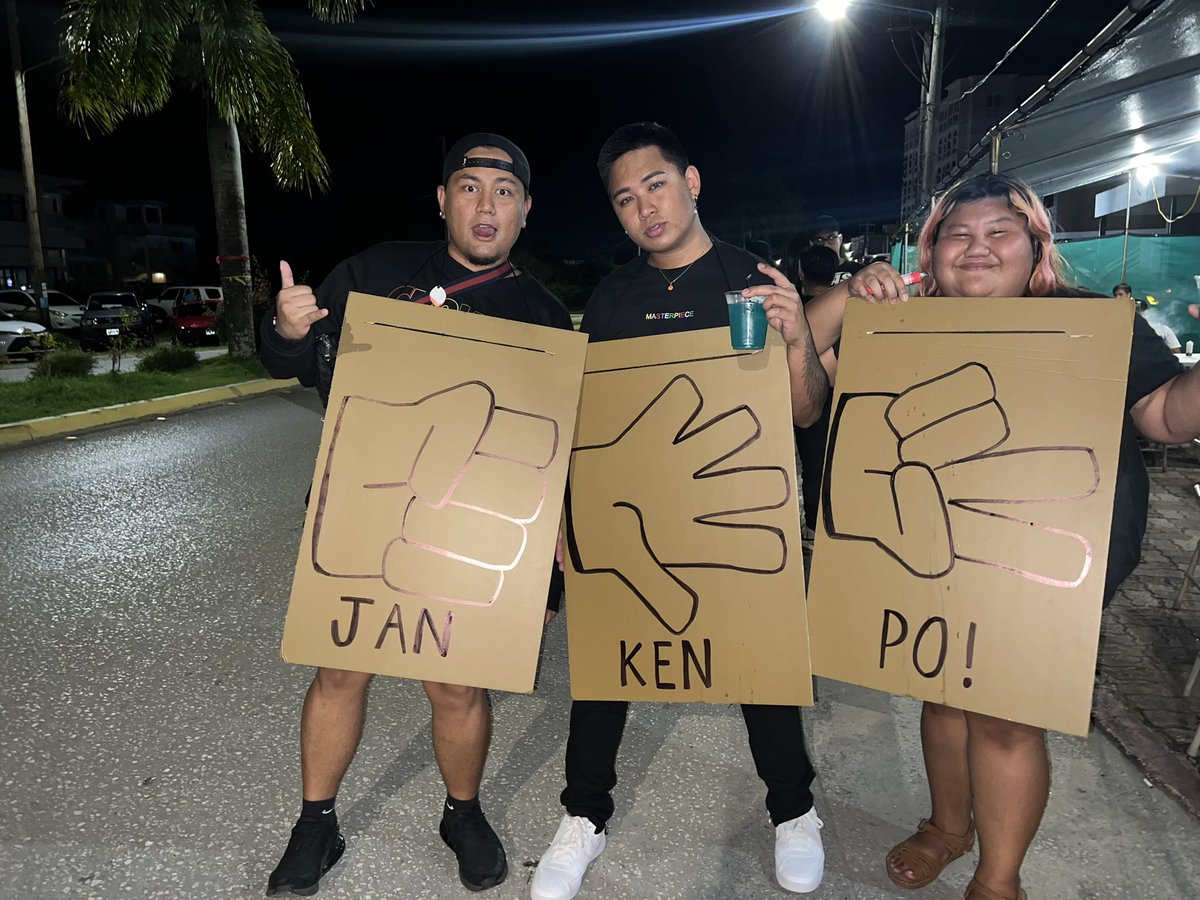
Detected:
[{"left": 566, "top": 376, "right": 793, "bottom": 635}]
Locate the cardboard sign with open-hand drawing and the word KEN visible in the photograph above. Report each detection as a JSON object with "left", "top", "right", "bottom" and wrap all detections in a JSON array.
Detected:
[{"left": 566, "top": 329, "right": 812, "bottom": 704}]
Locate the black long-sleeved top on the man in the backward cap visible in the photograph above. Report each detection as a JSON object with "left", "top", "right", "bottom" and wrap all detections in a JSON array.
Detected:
[{"left": 258, "top": 241, "right": 572, "bottom": 401}]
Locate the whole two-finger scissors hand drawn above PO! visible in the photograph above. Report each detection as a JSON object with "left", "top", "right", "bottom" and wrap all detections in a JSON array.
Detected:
[{"left": 822, "top": 362, "right": 1099, "bottom": 587}]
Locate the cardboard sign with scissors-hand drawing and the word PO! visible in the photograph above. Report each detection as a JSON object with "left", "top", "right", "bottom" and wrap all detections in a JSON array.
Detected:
[{"left": 809, "top": 298, "right": 1133, "bottom": 734}]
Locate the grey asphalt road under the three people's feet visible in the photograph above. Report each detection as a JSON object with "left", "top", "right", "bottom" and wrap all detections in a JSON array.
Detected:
[{"left": 0, "top": 390, "right": 1200, "bottom": 900}]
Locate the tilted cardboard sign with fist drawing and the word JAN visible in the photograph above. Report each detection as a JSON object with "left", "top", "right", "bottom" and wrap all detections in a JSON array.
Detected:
[{"left": 283, "top": 294, "right": 587, "bottom": 691}]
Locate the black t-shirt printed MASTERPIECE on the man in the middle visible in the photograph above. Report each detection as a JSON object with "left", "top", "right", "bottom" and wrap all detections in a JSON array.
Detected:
[{"left": 580, "top": 238, "right": 772, "bottom": 341}]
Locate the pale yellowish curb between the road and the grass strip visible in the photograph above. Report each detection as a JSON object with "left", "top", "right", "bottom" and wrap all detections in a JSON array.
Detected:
[{"left": 0, "top": 378, "right": 300, "bottom": 448}]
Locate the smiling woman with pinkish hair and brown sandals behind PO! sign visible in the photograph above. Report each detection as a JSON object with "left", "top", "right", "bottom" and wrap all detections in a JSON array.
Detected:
[{"left": 805, "top": 175, "right": 1200, "bottom": 900}]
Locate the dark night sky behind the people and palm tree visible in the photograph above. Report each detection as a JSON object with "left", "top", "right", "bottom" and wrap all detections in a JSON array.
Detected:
[{"left": 0, "top": 0, "right": 1124, "bottom": 280}]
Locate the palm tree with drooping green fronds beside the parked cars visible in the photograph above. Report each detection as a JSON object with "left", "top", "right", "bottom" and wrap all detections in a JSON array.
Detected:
[{"left": 60, "top": 0, "right": 372, "bottom": 358}]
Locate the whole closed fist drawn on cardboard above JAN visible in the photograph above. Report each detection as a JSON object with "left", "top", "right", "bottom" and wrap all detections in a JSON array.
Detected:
[{"left": 312, "top": 382, "right": 558, "bottom": 606}]
